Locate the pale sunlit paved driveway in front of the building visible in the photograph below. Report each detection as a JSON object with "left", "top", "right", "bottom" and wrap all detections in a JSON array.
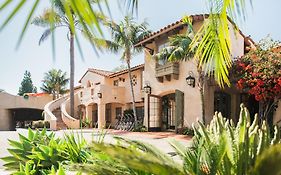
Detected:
[{"left": 0, "top": 129, "right": 191, "bottom": 175}]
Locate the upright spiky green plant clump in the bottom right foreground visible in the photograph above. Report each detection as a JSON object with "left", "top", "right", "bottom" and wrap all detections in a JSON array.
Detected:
[{"left": 172, "top": 105, "right": 280, "bottom": 175}]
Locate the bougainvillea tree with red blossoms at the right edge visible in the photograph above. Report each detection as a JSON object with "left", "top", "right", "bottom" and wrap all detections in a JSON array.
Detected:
[{"left": 233, "top": 37, "right": 281, "bottom": 121}]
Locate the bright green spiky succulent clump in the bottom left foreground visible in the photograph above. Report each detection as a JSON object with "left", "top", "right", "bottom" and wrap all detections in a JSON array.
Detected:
[{"left": 2, "top": 129, "right": 89, "bottom": 174}]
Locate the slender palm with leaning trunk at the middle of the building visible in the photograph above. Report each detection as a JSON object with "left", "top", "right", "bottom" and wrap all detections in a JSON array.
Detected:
[{"left": 99, "top": 16, "right": 149, "bottom": 124}]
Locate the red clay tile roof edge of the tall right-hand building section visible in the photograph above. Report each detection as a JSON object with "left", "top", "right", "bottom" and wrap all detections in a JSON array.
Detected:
[{"left": 135, "top": 14, "right": 255, "bottom": 47}]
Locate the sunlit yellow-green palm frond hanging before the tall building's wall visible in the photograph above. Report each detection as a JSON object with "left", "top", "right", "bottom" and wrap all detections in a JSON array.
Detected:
[{"left": 191, "top": 14, "right": 232, "bottom": 87}]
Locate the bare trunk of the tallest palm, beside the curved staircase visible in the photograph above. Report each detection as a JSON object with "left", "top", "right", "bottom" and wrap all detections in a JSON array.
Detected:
[{"left": 70, "top": 32, "right": 75, "bottom": 118}]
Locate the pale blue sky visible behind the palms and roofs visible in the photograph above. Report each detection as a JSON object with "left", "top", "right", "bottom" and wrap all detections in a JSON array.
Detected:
[{"left": 0, "top": 0, "right": 281, "bottom": 94}]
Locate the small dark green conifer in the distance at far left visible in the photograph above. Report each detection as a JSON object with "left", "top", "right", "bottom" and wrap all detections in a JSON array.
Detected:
[{"left": 18, "top": 71, "right": 37, "bottom": 96}]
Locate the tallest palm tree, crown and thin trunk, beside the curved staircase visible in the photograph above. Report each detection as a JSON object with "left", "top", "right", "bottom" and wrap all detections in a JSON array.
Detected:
[{"left": 32, "top": 0, "right": 104, "bottom": 117}]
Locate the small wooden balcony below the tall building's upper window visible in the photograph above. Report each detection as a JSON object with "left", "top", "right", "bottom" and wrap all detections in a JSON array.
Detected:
[{"left": 155, "top": 63, "right": 179, "bottom": 82}]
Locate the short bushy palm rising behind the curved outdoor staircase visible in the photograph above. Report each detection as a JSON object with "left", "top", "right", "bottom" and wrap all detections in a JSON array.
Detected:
[{"left": 41, "top": 69, "right": 69, "bottom": 100}]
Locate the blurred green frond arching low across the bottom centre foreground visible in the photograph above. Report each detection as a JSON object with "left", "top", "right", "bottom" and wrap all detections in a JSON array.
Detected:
[{"left": 74, "top": 138, "right": 184, "bottom": 175}]
